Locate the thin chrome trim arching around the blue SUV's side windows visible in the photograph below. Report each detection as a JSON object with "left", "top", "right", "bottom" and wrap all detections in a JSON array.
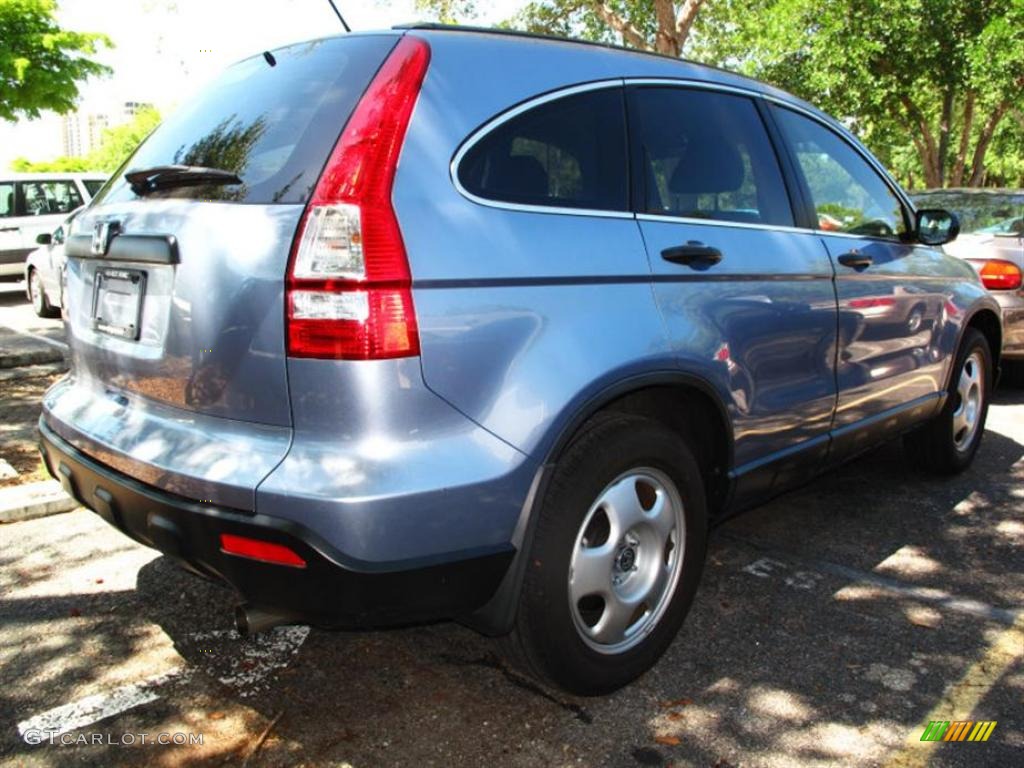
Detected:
[{"left": 449, "top": 77, "right": 919, "bottom": 246}]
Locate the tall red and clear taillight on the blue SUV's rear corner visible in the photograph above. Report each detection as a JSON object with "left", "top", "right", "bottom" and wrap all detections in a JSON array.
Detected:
[{"left": 287, "top": 37, "right": 430, "bottom": 359}]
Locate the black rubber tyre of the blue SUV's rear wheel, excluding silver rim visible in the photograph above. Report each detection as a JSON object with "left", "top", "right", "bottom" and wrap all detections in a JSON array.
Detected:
[{"left": 505, "top": 414, "right": 708, "bottom": 695}]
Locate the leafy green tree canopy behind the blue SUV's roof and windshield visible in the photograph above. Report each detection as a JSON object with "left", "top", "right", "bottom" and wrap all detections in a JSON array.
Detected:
[{"left": 411, "top": 0, "right": 1024, "bottom": 187}]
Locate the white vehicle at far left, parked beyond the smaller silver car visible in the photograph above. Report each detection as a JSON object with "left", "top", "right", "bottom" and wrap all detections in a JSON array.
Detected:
[{"left": 0, "top": 173, "right": 106, "bottom": 281}]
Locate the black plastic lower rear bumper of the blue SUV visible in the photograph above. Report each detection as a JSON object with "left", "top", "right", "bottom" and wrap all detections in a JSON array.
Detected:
[{"left": 39, "top": 420, "right": 514, "bottom": 627}]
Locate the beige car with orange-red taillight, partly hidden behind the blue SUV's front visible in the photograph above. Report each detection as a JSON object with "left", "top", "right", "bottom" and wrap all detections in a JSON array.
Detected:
[{"left": 914, "top": 189, "right": 1024, "bottom": 386}]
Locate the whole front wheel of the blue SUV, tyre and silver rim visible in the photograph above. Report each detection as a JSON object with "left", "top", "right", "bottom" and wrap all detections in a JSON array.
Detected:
[{"left": 903, "top": 328, "right": 992, "bottom": 474}]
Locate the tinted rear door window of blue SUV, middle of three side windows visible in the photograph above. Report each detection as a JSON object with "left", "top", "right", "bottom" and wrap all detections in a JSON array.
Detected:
[{"left": 628, "top": 86, "right": 794, "bottom": 226}]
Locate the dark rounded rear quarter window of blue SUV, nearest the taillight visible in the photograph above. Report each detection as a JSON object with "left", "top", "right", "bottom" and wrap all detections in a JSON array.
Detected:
[{"left": 458, "top": 88, "right": 629, "bottom": 211}]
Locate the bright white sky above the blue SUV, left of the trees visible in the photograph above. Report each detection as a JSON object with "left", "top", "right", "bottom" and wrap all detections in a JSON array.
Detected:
[{"left": 0, "top": 0, "right": 523, "bottom": 169}]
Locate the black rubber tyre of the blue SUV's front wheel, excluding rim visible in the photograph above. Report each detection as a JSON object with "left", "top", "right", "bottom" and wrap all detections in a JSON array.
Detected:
[{"left": 903, "top": 328, "right": 993, "bottom": 475}]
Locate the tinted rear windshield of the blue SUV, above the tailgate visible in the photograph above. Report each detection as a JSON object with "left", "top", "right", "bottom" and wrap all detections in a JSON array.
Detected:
[{"left": 97, "top": 35, "right": 397, "bottom": 204}]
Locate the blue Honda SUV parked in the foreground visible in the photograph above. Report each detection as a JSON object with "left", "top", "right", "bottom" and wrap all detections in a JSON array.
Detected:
[{"left": 40, "top": 26, "right": 1001, "bottom": 694}]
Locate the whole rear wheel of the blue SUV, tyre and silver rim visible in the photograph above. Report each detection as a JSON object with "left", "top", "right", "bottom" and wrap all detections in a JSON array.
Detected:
[{"left": 508, "top": 415, "right": 707, "bottom": 695}]
